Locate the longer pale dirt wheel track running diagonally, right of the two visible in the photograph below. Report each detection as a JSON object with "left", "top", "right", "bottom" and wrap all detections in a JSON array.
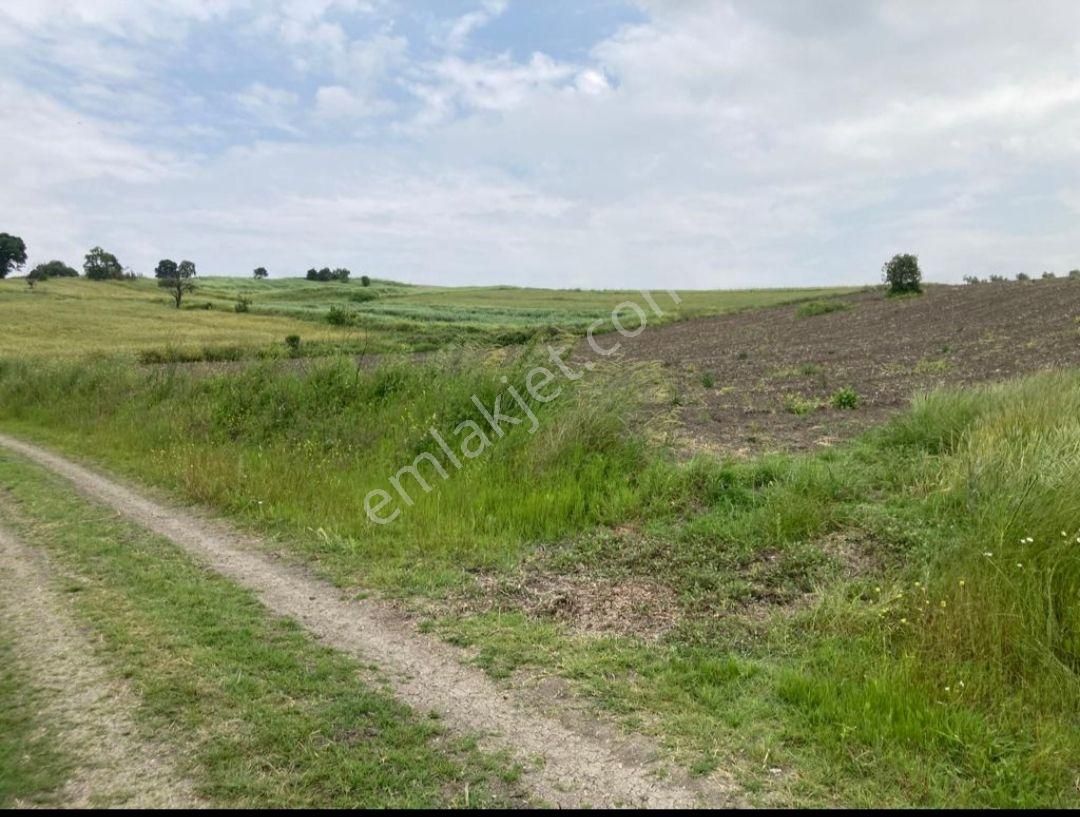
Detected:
[{"left": 0, "top": 434, "right": 738, "bottom": 807}]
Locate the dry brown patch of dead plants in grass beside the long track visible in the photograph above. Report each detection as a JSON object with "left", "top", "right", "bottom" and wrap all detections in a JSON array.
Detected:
[{"left": 470, "top": 573, "right": 679, "bottom": 641}]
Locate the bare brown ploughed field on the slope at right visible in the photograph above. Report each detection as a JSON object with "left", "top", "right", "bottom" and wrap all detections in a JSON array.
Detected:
[{"left": 600, "top": 280, "right": 1080, "bottom": 454}]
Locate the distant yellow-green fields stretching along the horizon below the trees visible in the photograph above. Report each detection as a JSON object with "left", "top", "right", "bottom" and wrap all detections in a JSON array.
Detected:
[{"left": 0, "top": 278, "right": 859, "bottom": 363}]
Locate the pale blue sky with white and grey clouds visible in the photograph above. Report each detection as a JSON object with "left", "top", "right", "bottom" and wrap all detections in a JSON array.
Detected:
[{"left": 0, "top": 0, "right": 1080, "bottom": 289}]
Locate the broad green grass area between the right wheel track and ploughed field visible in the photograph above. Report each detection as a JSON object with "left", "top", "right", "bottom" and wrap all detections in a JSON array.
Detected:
[{"left": 0, "top": 356, "right": 1080, "bottom": 806}]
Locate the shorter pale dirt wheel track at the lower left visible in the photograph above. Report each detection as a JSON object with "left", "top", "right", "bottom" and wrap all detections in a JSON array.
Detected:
[{"left": 0, "top": 530, "right": 206, "bottom": 808}]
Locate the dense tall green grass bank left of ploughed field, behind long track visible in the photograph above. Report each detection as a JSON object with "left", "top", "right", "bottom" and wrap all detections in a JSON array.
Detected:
[{"left": 0, "top": 354, "right": 648, "bottom": 587}]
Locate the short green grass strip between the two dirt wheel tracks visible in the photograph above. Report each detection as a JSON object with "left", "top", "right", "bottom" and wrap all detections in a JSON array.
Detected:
[{"left": 0, "top": 455, "right": 524, "bottom": 807}]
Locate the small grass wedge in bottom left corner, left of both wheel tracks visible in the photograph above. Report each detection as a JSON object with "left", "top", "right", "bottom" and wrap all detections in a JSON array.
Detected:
[{"left": 0, "top": 628, "right": 68, "bottom": 808}]
